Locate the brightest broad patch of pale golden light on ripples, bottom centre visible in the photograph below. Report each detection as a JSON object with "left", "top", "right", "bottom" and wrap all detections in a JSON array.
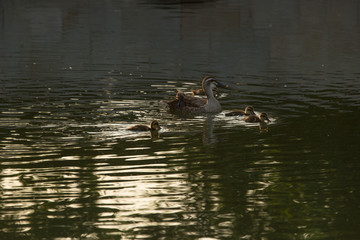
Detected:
[{"left": 97, "top": 164, "right": 191, "bottom": 231}]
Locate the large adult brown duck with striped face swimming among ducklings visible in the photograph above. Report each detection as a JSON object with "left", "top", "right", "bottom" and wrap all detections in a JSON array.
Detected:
[{"left": 166, "top": 77, "right": 227, "bottom": 113}]
